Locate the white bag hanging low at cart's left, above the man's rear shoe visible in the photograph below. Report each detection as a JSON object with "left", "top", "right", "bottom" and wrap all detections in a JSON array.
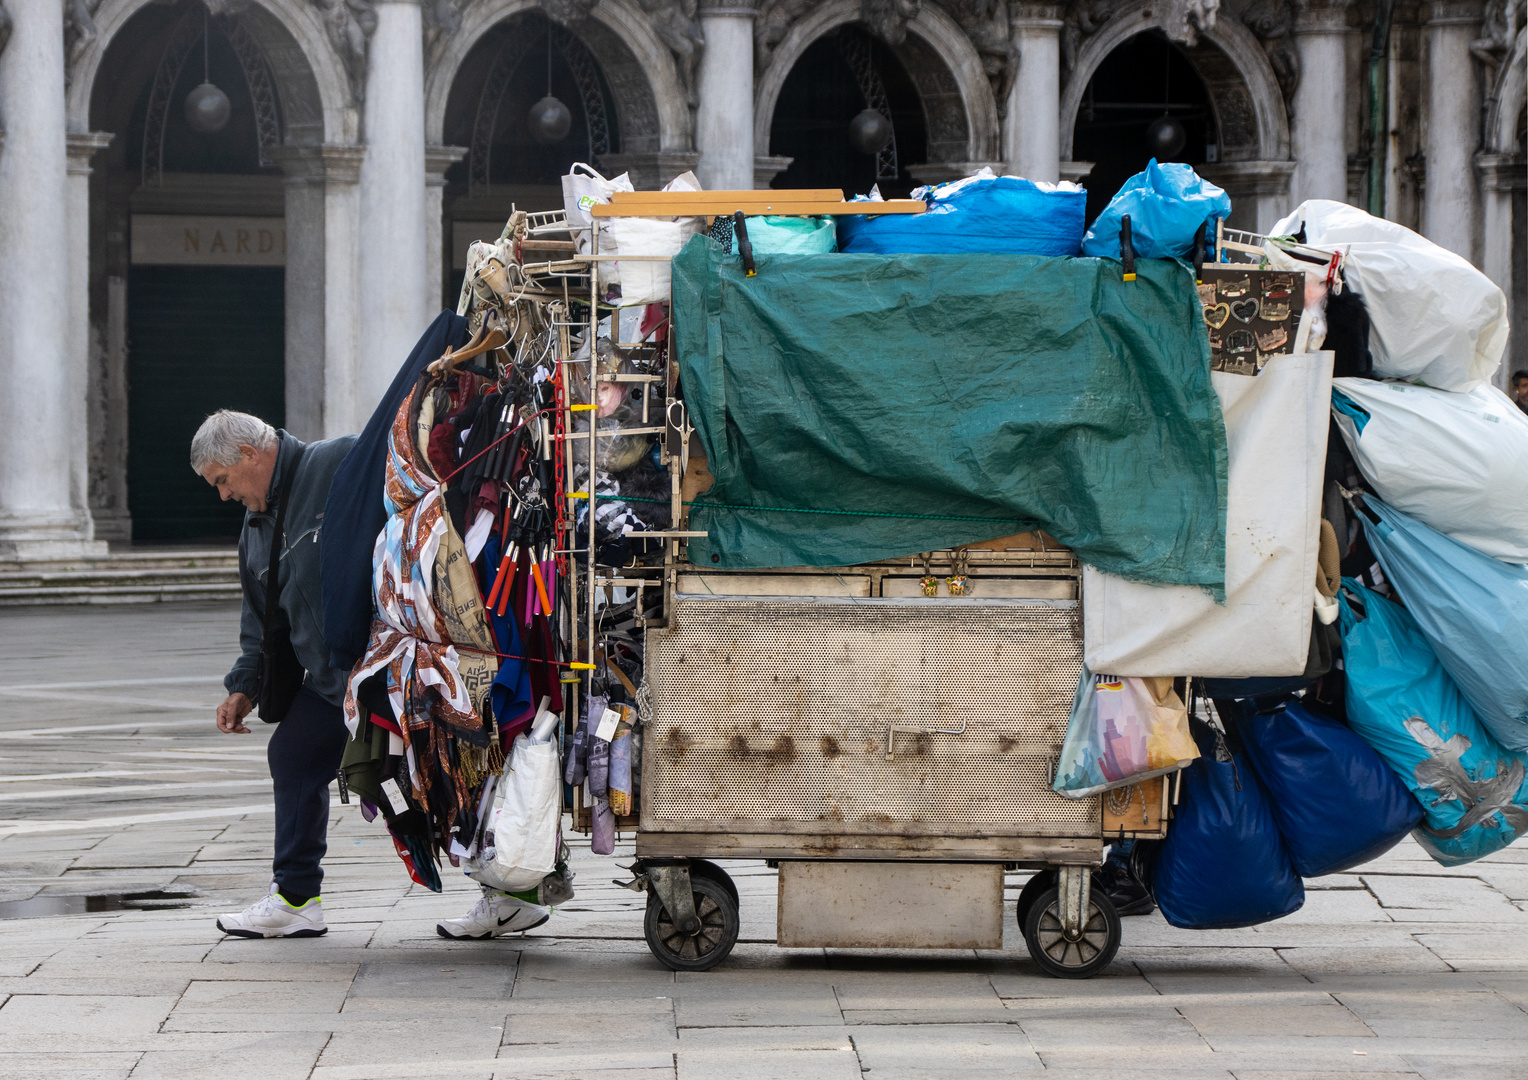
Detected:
[{"left": 471, "top": 735, "right": 562, "bottom": 892}]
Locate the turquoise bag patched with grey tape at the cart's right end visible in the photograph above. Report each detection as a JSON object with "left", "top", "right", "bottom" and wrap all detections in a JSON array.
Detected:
[{"left": 1337, "top": 577, "right": 1528, "bottom": 866}]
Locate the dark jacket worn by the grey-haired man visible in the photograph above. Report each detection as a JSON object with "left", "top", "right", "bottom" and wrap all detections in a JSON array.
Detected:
[{"left": 223, "top": 431, "right": 356, "bottom": 704}]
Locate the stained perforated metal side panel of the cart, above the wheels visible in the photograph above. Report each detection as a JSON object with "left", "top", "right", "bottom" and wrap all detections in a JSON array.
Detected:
[{"left": 642, "top": 594, "right": 1099, "bottom": 837}]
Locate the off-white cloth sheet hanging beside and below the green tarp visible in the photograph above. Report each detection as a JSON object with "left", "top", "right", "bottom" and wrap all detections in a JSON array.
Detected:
[{"left": 1082, "top": 353, "right": 1332, "bottom": 678}]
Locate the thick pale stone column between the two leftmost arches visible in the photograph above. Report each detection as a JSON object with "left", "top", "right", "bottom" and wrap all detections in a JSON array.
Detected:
[{"left": 356, "top": 0, "right": 431, "bottom": 416}]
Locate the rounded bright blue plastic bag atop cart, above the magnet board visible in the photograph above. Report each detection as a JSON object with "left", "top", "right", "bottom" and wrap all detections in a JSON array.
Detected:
[{"left": 1082, "top": 157, "right": 1232, "bottom": 258}]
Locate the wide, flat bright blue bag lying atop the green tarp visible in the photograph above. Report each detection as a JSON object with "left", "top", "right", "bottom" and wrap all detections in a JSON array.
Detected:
[{"left": 839, "top": 176, "right": 1088, "bottom": 255}]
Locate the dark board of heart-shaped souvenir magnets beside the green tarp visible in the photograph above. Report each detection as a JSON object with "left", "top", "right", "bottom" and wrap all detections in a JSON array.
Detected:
[{"left": 1199, "top": 266, "right": 1305, "bottom": 374}]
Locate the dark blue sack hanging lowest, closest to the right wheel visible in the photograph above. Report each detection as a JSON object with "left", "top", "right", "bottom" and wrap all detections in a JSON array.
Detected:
[{"left": 1151, "top": 724, "right": 1305, "bottom": 930}]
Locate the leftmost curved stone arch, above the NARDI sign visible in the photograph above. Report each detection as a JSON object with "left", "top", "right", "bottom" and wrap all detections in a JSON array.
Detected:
[{"left": 66, "top": 0, "right": 349, "bottom": 145}]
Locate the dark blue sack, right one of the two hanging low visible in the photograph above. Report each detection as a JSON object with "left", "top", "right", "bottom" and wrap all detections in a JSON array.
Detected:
[{"left": 1236, "top": 701, "right": 1423, "bottom": 877}]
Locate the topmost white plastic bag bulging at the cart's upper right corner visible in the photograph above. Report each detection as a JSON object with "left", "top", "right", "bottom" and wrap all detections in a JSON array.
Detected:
[{"left": 1270, "top": 199, "right": 1507, "bottom": 393}]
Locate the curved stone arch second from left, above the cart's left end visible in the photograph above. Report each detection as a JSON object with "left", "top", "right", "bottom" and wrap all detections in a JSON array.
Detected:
[{"left": 425, "top": 0, "right": 678, "bottom": 154}]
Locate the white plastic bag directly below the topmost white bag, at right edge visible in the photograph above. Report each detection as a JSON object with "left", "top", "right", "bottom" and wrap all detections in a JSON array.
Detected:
[{"left": 1332, "top": 379, "right": 1528, "bottom": 562}]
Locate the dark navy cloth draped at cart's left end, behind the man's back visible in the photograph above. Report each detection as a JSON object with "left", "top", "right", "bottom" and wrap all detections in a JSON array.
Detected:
[{"left": 322, "top": 312, "right": 468, "bottom": 678}]
